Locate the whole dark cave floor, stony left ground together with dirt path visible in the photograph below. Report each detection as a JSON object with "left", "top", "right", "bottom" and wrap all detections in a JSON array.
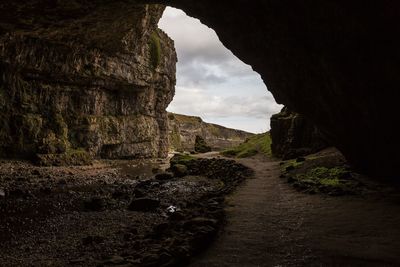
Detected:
[{"left": 0, "top": 153, "right": 400, "bottom": 267}]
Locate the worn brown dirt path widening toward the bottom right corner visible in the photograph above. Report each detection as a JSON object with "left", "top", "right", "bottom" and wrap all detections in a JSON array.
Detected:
[{"left": 191, "top": 158, "right": 400, "bottom": 267}]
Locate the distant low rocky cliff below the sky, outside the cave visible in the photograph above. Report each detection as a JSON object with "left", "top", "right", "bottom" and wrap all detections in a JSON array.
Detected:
[{"left": 168, "top": 113, "right": 253, "bottom": 151}]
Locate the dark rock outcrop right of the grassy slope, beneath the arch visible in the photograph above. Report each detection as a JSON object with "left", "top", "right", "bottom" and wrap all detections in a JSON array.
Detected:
[{"left": 270, "top": 107, "right": 328, "bottom": 159}]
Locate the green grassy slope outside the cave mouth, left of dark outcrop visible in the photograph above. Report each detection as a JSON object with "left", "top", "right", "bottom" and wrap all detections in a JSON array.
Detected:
[{"left": 221, "top": 132, "right": 271, "bottom": 158}]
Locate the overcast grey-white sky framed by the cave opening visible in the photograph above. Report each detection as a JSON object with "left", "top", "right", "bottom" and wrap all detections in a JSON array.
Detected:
[{"left": 159, "top": 7, "right": 282, "bottom": 133}]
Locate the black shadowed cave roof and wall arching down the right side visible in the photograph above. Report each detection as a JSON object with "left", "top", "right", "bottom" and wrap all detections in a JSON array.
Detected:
[{"left": 153, "top": 0, "right": 400, "bottom": 178}]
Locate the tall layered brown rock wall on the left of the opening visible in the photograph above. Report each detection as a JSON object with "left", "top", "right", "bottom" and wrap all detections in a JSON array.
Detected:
[{"left": 0, "top": 2, "right": 176, "bottom": 161}]
